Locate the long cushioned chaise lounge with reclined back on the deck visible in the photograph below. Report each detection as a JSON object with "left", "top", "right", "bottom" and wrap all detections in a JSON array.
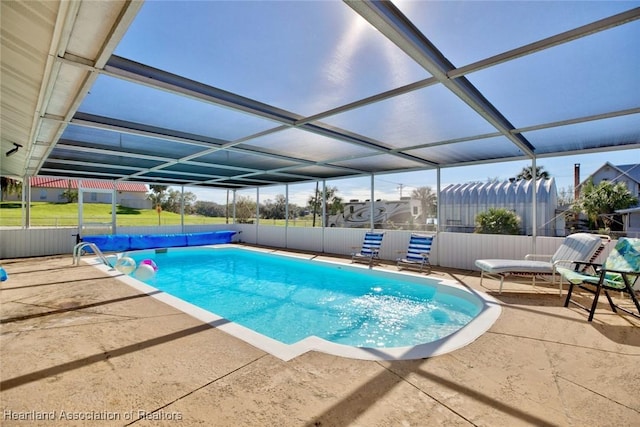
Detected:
[{"left": 476, "top": 233, "right": 610, "bottom": 296}]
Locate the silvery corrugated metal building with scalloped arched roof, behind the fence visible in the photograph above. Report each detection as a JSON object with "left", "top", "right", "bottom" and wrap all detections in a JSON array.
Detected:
[{"left": 439, "top": 178, "right": 564, "bottom": 236}]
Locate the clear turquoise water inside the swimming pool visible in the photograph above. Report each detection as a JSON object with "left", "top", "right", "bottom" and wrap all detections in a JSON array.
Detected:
[{"left": 126, "top": 248, "right": 482, "bottom": 348}]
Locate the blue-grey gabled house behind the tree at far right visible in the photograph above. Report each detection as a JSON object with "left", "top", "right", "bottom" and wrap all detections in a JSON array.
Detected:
[{"left": 580, "top": 162, "right": 640, "bottom": 237}]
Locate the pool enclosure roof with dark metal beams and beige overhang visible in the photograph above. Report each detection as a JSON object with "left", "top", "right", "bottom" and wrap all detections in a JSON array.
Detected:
[{"left": 0, "top": 0, "right": 640, "bottom": 189}]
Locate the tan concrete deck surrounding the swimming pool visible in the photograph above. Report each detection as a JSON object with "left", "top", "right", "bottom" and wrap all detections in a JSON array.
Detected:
[{"left": 0, "top": 249, "right": 640, "bottom": 426}]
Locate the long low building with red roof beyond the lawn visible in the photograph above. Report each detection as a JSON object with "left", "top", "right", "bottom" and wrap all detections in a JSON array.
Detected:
[{"left": 5, "top": 176, "right": 151, "bottom": 209}]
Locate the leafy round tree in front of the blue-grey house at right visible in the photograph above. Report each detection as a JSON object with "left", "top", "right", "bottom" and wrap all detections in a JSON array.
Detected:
[{"left": 574, "top": 180, "right": 638, "bottom": 234}]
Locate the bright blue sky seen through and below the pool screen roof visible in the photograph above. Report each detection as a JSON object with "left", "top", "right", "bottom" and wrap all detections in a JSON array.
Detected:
[{"left": 114, "top": 1, "right": 640, "bottom": 205}]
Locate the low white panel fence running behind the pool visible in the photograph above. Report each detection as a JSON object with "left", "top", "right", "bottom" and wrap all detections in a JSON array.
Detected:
[{"left": 0, "top": 224, "right": 613, "bottom": 270}]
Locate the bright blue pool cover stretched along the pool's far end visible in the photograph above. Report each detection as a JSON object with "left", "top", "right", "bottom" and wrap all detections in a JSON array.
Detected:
[{"left": 82, "top": 230, "right": 237, "bottom": 252}]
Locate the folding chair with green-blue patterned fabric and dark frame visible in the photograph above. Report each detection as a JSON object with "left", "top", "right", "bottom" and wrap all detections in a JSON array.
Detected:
[{"left": 558, "top": 237, "right": 640, "bottom": 322}]
